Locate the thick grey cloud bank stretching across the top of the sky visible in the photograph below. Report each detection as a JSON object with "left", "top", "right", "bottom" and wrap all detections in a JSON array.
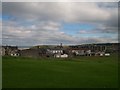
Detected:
[{"left": 3, "top": 2, "right": 118, "bottom": 30}]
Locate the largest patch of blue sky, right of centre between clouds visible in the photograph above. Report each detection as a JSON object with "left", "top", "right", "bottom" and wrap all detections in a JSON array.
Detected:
[{"left": 61, "top": 23, "right": 95, "bottom": 36}]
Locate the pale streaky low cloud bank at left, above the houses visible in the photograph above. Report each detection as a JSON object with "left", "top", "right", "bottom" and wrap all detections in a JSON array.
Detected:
[{"left": 2, "top": 19, "right": 74, "bottom": 45}]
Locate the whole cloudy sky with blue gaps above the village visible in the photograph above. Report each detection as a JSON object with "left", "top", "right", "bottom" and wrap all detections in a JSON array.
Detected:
[{"left": 2, "top": 2, "right": 118, "bottom": 46}]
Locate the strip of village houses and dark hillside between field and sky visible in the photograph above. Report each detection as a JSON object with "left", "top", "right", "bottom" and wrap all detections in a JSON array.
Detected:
[{"left": 0, "top": 43, "right": 119, "bottom": 58}]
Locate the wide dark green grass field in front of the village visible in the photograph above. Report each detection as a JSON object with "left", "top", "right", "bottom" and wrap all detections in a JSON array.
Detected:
[{"left": 2, "top": 55, "right": 118, "bottom": 88}]
